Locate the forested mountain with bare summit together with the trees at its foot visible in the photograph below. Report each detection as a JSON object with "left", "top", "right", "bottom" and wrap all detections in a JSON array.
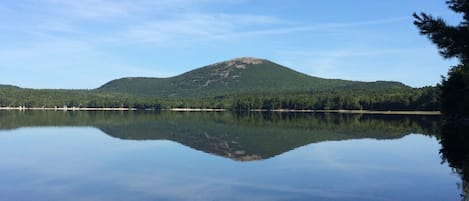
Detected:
[{"left": 0, "top": 58, "right": 440, "bottom": 111}]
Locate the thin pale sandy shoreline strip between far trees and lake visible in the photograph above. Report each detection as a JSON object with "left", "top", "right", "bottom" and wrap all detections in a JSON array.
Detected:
[{"left": 0, "top": 107, "right": 441, "bottom": 115}]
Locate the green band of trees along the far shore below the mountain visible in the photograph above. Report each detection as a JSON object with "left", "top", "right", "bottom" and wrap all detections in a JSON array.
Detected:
[{"left": 0, "top": 87, "right": 440, "bottom": 111}]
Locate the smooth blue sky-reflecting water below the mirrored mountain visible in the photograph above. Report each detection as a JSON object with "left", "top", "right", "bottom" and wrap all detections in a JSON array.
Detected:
[{"left": 0, "top": 112, "right": 461, "bottom": 201}]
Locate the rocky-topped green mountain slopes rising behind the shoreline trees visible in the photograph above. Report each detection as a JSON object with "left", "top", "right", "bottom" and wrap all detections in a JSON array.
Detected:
[{"left": 96, "top": 57, "right": 410, "bottom": 97}]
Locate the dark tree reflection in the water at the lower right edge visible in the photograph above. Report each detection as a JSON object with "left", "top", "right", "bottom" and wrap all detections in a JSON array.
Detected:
[{"left": 440, "top": 122, "right": 469, "bottom": 200}]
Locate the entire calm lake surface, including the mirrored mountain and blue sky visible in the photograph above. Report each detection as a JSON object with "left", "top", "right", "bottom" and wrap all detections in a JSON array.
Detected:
[{"left": 0, "top": 111, "right": 469, "bottom": 201}]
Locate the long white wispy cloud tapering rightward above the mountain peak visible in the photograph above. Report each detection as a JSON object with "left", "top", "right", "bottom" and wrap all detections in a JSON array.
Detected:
[{"left": 124, "top": 13, "right": 408, "bottom": 43}]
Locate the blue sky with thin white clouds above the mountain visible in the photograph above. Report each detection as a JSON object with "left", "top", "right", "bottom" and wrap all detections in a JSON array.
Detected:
[{"left": 0, "top": 0, "right": 461, "bottom": 89}]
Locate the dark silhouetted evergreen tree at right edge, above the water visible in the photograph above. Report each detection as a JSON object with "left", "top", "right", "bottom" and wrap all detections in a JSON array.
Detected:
[{"left": 413, "top": 0, "right": 469, "bottom": 116}]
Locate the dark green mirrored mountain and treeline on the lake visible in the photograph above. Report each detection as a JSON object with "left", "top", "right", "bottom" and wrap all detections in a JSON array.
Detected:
[{"left": 0, "top": 111, "right": 439, "bottom": 161}]
